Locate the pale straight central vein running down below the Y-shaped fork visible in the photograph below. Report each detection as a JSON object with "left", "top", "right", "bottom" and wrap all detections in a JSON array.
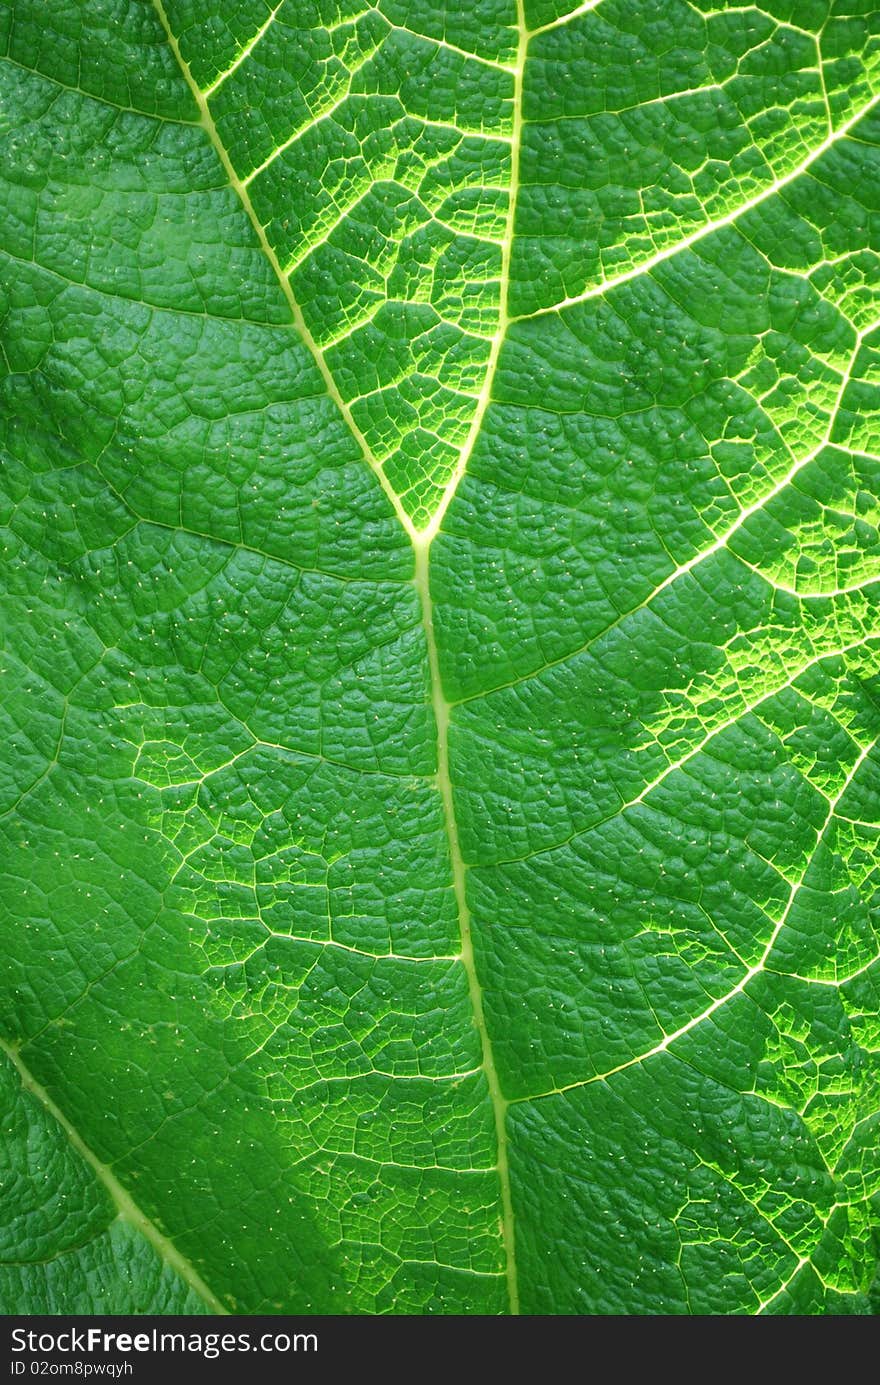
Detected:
[{"left": 414, "top": 543, "right": 520, "bottom": 1313}]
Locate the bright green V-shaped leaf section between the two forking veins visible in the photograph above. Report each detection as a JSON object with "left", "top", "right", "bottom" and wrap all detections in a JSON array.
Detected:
[{"left": 182, "top": 0, "right": 525, "bottom": 533}]
